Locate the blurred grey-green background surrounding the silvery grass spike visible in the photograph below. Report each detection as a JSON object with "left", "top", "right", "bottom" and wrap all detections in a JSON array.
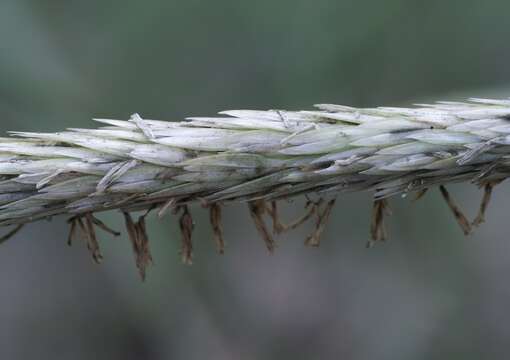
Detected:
[{"left": 0, "top": 0, "right": 510, "bottom": 360}]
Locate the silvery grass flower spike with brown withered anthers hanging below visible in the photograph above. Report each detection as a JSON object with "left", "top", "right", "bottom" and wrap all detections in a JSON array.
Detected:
[{"left": 0, "top": 99, "right": 510, "bottom": 277}]
